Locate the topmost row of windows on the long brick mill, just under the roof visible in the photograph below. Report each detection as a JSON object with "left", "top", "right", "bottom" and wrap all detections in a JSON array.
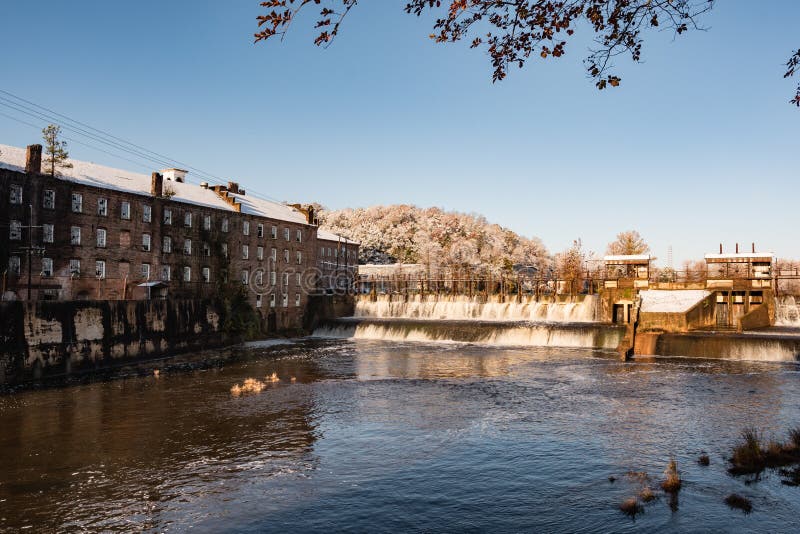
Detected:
[{"left": 9, "top": 184, "right": 303, "bottom": 243}]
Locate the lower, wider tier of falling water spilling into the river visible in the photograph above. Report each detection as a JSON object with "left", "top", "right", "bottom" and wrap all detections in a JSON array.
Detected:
[{"left": 314, "top": 318, "right": 624, "bottom": 350}]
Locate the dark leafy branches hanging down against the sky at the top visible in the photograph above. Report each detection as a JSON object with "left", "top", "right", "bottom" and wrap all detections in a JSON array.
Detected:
[{"left": 255, "top": 0, "right": 800, "bottom": 106}]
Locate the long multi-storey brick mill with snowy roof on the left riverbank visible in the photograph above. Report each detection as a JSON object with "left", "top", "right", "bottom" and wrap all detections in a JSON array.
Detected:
[{"left": 0, "top": 145, "right": 358, "bottom": 328}]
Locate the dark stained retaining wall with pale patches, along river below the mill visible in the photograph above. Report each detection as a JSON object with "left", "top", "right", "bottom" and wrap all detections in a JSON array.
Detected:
[{"left": 0, "top": 300, "right": 228, "bottom": 385}]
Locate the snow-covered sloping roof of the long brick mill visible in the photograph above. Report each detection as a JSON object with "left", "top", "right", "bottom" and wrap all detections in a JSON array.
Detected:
[{"left": 0, "top": 145, "right": 308, "bottom": 224}]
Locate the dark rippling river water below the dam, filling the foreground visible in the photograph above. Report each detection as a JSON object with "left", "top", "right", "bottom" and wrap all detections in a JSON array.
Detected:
[{"left": 0, "top": 339, "right": 800, "bottom": 532}]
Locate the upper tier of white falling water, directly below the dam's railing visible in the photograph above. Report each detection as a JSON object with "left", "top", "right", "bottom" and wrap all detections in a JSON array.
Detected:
[{"left": 355, "top": 295, "right": 597, "bottom": 323}]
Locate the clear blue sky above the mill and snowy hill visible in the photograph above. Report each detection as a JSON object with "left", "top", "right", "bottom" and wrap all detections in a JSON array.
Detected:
[{"left": 0, "top": 0, "right": 800, "bottom": 267}]
